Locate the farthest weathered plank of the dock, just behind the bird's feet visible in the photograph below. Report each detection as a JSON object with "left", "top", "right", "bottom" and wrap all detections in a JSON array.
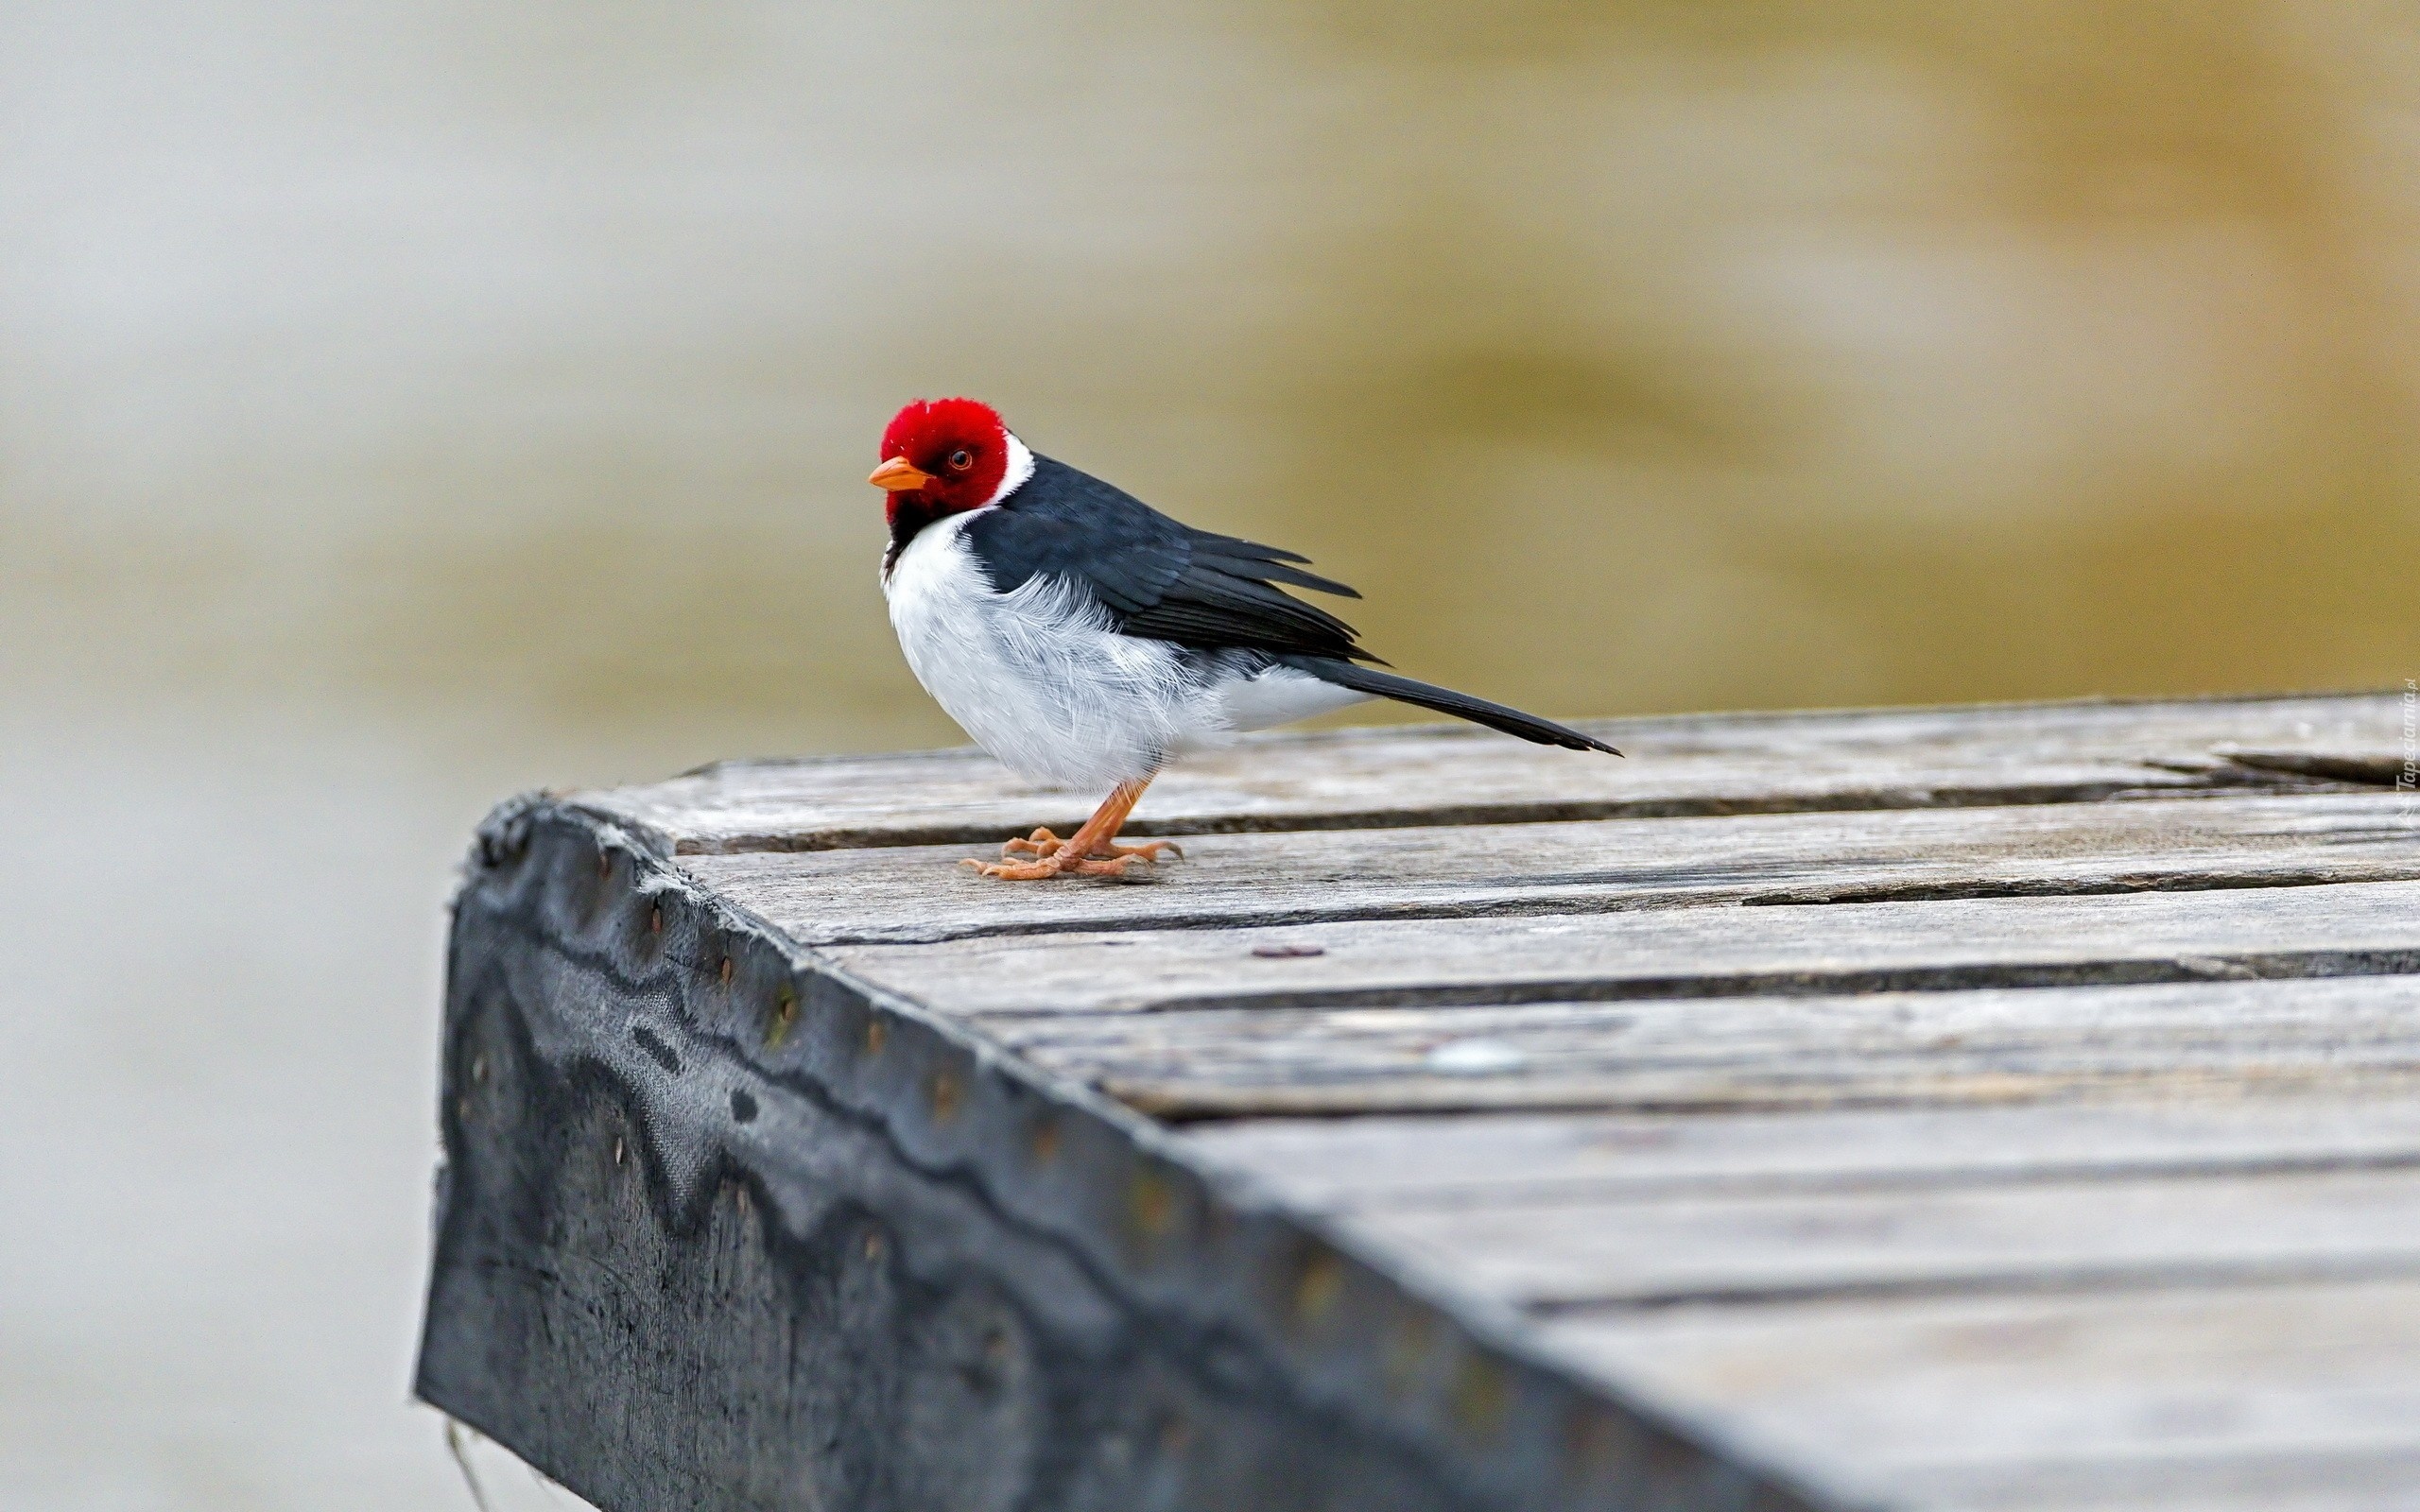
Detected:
[{"left": 576, "top": 695, "right": 2401, "bottom": 854}]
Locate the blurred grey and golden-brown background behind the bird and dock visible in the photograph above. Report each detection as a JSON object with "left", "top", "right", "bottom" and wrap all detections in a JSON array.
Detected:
[{"left": 0, "top": 0, "right": 2420, "bottom": 1512}]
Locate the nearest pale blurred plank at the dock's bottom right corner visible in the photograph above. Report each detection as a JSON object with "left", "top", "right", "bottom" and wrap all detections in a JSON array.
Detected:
[{"left": 1547, "top": 1280, "right": 2420, "bottom": 1512}]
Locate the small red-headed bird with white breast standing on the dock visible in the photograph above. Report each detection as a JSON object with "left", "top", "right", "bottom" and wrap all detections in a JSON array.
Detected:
[{"left": 866, "top": 399, "right": 1621, "bottom": 881}]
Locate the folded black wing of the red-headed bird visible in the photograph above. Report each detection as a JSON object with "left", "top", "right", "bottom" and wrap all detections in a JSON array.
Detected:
[{"left": 965, "top": 457, "right": 1384, "bottom": 665}]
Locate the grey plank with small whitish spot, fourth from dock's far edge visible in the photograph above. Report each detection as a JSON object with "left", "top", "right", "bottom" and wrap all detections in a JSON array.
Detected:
[{"left": 985, "top": 975, "right": 2420, "bottom": 1120}]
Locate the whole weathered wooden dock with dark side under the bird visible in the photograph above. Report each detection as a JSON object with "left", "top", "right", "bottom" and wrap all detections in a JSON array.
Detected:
[{"left": 419, "top": 695, "right": 2420, "bottom": 1512}]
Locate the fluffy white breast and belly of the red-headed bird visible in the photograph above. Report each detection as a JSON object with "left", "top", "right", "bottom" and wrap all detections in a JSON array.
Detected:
[{"left": 883, "top": 510, "right": 1229, "bottom": 789}]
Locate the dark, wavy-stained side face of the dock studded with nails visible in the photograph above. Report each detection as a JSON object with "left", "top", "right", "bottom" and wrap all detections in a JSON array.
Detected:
[{"left": 414, "top": 800, "right": 1820, "bottom": 1512}]
